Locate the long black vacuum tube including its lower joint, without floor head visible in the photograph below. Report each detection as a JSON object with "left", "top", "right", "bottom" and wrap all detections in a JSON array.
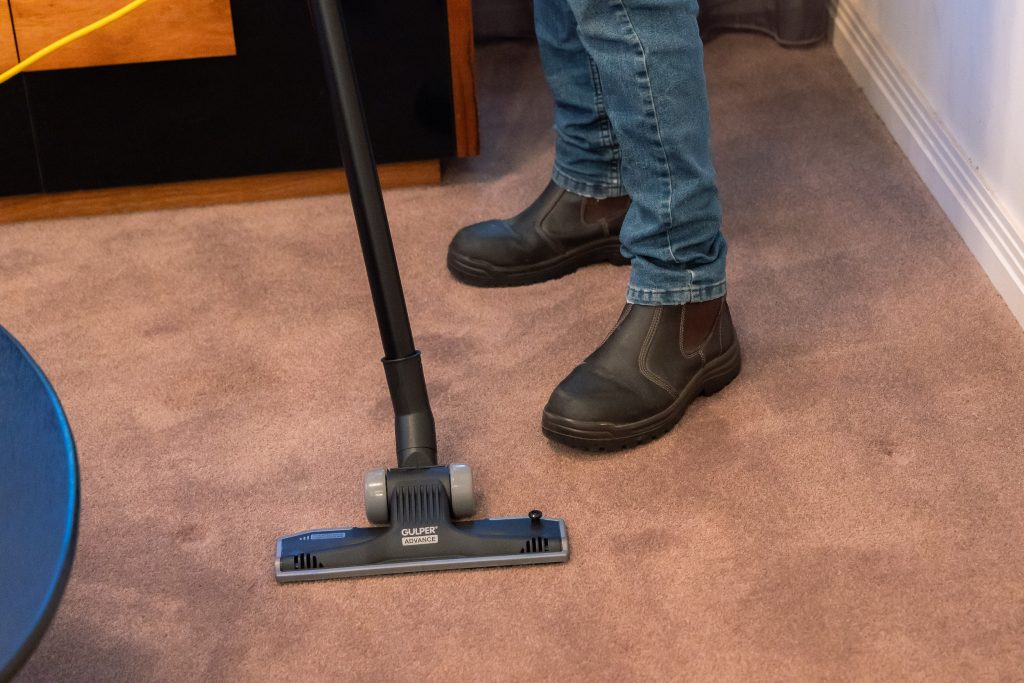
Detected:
[{"left": 311, "top": 0, "right": 437, "bottom": 467}]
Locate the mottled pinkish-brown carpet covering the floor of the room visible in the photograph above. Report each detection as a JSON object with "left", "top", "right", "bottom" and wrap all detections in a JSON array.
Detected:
[{"left": 6, "top": 35, "right": 1024, "bottom": 681}]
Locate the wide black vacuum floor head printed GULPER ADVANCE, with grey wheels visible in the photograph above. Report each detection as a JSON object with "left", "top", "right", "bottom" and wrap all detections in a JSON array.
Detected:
[{"left": 275, "top": 465, "right": 569, "bottom": 583}]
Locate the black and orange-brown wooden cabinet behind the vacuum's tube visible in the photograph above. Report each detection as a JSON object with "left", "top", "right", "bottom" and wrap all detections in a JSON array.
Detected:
[{"left": 0, "top": 0, "right": 478, "bottom": 223}]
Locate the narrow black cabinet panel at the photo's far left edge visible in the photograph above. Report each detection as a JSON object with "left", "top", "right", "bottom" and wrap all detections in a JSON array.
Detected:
[{"left": 0, "top": 78, "right": 42, "bottom": 197}]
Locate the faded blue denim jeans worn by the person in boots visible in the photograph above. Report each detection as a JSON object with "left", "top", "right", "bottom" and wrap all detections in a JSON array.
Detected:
[{"left": 534, "top": 0, "right": 726, "bottom": 304}]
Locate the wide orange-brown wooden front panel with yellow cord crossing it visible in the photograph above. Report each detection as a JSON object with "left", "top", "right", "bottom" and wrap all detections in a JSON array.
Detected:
[{"left": 9, "top": 0, "right": 234, "bottom": 70}]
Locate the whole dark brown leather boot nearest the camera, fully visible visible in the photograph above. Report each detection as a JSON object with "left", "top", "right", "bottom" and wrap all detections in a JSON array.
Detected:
[{"left": 542, "top": 297, "right": 740, "bottom": 451}]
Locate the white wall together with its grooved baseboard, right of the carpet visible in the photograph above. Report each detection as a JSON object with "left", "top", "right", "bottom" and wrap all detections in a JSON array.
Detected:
[{"left": 833, "top": 0, "right": 1024, "bottom": 325}]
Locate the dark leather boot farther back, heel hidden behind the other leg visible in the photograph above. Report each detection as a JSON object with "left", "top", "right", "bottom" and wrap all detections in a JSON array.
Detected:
[{"left": 447, "top": 182, "right": 630, "bottom": 287}]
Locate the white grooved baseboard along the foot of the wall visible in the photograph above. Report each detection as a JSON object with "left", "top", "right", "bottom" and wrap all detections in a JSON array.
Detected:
[{"left": 829, "top": 0, "right": 1024, "bottom": 327}]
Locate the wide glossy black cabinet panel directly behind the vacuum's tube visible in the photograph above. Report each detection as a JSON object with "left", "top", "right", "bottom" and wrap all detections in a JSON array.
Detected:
[{"left": 18, "top": 0, "right": 456, "bottom": 191}]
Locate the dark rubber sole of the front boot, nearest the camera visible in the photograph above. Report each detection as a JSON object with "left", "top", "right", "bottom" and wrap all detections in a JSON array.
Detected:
[{"left": 541, "top": 339, "right": 742, "bottom": 451}]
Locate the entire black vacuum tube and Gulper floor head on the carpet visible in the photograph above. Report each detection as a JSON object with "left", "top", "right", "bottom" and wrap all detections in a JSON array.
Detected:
[{"left": 274, "top": 0, "right": 569, "bottom": 583}]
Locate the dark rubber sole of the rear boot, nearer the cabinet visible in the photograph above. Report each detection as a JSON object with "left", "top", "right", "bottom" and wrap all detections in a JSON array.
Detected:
[{"left": 447, "top": 237, "right": 630, "bottom": 287}]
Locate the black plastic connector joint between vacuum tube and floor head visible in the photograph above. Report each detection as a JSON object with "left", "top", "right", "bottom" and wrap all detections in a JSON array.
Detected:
[{"left": 381, "top": 351, "right": 437, "bottom": 467}]
